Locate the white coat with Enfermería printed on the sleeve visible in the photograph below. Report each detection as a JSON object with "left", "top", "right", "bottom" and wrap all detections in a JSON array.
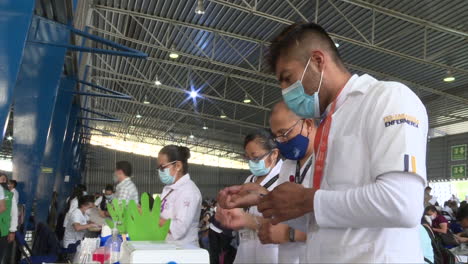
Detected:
[{"left": 307, "top": 75, "right": 428, "bottom": 263}]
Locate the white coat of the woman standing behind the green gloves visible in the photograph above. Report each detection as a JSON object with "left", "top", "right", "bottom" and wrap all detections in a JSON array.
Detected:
[{"left": 161, "top": 174, "right": 202, "bottom": 247}]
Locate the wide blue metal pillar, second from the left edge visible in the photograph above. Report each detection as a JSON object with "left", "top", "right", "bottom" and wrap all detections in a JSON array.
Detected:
[{"left": 13, "top": 16, "right": 69, "bottom": 227}]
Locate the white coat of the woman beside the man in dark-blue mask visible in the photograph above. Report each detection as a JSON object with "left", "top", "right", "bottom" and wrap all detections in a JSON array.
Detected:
[{"left": 234, "top": 160, "right": 283, "bottom": 264}]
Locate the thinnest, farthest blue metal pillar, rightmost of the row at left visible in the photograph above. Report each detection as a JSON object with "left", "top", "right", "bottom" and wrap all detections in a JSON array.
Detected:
[{"left": 54, "top": 104, "right": 80, "bottom": 212}]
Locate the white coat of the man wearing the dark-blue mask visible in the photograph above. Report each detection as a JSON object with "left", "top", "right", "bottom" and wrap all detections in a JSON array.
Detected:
[{"left": 278, "top": 154, "right": 315, "bottom": 264}]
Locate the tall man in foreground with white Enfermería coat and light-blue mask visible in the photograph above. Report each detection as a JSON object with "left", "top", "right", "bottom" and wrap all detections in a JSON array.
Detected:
[{"left": 223, "top": 23, "right": 428, "bottom": 263}]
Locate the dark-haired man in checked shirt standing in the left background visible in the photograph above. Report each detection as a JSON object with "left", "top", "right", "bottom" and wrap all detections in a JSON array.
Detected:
[{"left": 113, "top": 161, "right": 139, "bottom": 204}]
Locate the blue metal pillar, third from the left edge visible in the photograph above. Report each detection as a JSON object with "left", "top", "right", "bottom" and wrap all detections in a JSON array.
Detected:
[{"left": 35, "top": 78, "right": 76, "bottom": 222}]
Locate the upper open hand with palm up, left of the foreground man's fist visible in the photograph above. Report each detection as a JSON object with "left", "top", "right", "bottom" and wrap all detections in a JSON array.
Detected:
[{"left": 217, "top": 183, "right": 268, "bottom": 209}]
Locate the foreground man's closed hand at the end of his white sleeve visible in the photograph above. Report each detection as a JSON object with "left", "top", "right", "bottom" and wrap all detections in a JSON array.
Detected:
[{"left": 258, "top": 182, "right": 315, "bottom": 225}]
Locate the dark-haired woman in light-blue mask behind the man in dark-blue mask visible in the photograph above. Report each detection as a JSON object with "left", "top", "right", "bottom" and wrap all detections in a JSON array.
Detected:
[{"left": 218, "top": 130, "right": 284, "bottom": 263}]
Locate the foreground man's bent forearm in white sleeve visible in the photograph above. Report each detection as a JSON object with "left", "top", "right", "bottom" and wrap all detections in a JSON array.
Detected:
[{"left": 313, "top": 173, "right": 424, "bottom": 228}]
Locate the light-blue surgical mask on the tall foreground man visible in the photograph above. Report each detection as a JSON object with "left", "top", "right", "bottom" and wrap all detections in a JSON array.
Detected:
[{"left": 282, "top": 58, "right": 323, "bottom": 118}]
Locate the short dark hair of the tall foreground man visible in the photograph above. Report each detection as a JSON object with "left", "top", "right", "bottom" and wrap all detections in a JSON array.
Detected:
[{"left": 269, "top": 23, "right": 344, "bottom": 71}]
